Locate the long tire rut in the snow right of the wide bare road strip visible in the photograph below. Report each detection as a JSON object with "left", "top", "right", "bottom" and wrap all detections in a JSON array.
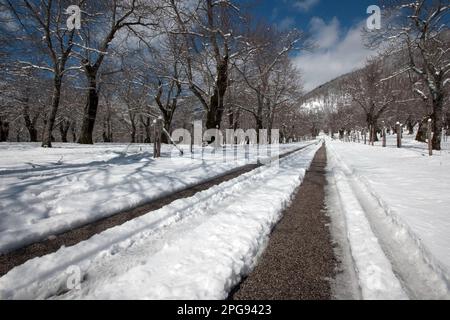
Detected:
[{"left": 330, "top": 147, "right": 450, "bottom": 299}]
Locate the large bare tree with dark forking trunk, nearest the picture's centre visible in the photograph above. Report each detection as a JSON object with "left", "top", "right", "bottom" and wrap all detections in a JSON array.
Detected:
[{"left": 167, "top": 0, "right": 244, "bottom": 129}]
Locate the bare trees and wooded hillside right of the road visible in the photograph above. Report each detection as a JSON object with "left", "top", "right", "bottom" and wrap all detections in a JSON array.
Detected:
[{"left": 306, "top": 0, "right": 450, "bottom": 150}]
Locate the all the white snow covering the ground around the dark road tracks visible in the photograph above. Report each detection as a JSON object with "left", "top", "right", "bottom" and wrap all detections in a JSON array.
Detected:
[{"left": 0, "top": 135, "right": 450, "bottom": 299}]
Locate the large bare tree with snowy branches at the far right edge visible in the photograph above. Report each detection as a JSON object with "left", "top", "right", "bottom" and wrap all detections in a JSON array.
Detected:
[{"left": 371, "top": 0, "right": 450, "bottom": 150}]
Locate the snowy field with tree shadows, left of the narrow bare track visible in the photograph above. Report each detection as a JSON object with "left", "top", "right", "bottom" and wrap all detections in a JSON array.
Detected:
[{"left": 0, "top": 142, "right": 307, "bottom": 253}]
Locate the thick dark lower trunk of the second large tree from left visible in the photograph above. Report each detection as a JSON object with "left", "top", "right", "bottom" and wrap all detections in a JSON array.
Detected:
[{"left": 78, "top": 71, "right": 98, "bottom": 144}]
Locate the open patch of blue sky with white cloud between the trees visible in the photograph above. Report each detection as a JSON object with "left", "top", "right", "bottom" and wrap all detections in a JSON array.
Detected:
[{"left": 252, "top": 0, "right": 378, "bottom": 91}]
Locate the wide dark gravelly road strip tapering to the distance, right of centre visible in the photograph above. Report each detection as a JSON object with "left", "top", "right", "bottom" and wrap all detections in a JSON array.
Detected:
[{"left": 230, "top": 146, "right": 336, "bottom": 300}]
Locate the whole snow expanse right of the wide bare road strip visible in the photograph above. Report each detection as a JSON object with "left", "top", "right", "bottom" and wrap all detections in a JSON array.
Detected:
[{"left": 327, "top": 136, "right": 450, "bottom": 299}]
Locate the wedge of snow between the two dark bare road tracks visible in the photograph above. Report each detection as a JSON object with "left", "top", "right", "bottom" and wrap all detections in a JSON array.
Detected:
[{"left": 0, "top": 144, "right": 320, "bottom": 299}]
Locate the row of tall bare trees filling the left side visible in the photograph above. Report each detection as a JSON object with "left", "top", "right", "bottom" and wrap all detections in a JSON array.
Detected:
[{"left": 0, "top": 0, "right": 311, "bottom": 147}]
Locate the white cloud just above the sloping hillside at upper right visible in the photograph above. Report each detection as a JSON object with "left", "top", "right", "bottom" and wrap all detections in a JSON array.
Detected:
[{"left": 293, "top": 18, "right": 374, "bottom": 91}]
